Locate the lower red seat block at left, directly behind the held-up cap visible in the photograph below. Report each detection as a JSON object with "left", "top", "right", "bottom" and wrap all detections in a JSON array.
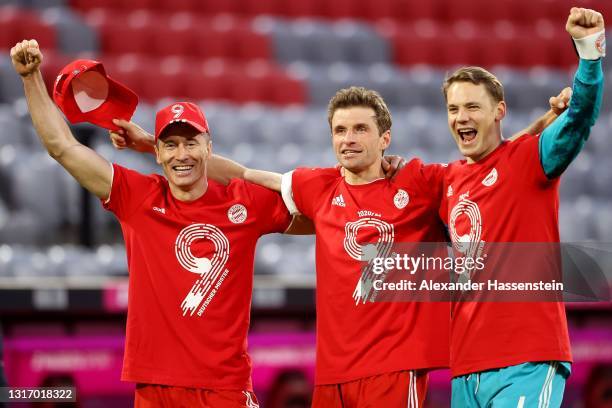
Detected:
[{"left": 43, "top": 54, "right": 307, "bottom": 105}]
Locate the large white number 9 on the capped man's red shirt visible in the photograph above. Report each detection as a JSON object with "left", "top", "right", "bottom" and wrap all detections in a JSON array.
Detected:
[{"left": 174, "top": 224, "right": 229, "bottom": 316}]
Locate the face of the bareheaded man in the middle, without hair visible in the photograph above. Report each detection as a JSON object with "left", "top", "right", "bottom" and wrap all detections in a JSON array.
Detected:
[{"left": 331, "top": 106, "right": 391, "bottom": 181}]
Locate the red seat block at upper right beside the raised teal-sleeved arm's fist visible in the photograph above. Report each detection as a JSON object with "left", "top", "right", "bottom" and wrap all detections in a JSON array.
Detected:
[{"left": 381, "top": 21, "right": 577, "bottom": 69}]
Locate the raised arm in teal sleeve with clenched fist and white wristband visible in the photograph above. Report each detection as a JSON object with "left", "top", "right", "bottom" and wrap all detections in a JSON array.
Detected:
[{"left": 539, "top": 8, "right": 605, "bottom": 178}]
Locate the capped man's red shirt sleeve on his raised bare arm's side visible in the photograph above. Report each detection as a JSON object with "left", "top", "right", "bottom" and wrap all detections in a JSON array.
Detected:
[{"left": 102, "top": 164, "right": 157, "bottom": 220}]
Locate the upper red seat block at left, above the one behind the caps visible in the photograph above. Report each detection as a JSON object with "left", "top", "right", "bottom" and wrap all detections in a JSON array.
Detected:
[{"left": 85, "top": 10, "right": 273, "bottom": 60}]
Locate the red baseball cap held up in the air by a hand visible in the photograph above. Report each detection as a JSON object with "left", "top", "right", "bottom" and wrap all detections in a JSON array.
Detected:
[{"left": 53, "top": 59, "right": 138, "bottom": 130}]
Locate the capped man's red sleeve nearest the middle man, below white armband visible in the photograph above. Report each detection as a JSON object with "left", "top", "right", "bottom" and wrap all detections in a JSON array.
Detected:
[{"left": 247, "top": 183, "right": 291, "bottom": 234}]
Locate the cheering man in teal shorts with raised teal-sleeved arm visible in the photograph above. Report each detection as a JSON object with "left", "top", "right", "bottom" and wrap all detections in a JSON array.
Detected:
[{"left": 442, "top": 8, "right": 605, "bottom": 408}]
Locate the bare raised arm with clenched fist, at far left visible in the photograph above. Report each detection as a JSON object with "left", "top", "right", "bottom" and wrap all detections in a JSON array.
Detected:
[{"left": 11, "top": 40, "right": 113, "bottom": 199}]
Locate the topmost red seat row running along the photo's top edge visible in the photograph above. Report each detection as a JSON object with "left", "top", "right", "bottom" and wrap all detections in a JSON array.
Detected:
[{"left": 71, "top": 0, "right": 612, "bottom": 24}]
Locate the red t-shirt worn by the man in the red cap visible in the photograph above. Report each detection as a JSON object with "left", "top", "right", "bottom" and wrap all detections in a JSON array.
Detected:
[{"left": 104, "top": 165, "right": 290, "bottom": 391}]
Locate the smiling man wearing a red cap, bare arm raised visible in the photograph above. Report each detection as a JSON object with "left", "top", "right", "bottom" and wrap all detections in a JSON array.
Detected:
[{"left": 11, "top": 40, "right": 291, "bottom": 407}]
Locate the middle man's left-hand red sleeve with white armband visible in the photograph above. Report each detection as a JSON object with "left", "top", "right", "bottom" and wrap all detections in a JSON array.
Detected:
[{"left": 281, "top": 168, "right": 340, "bottom": 221}]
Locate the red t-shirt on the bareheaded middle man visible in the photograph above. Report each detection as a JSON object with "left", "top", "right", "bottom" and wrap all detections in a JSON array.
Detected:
[{"left": 291, "top": 160, "right": 450, "bottom": 385}]
